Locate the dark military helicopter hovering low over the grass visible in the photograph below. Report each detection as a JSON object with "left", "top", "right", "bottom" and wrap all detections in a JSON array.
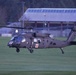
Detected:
[{"left": 2, "top": 27, "right": 76, "bottom": 54}]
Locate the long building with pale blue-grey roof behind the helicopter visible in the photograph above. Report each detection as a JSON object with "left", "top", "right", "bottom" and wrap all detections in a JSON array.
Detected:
[{"left": 19, "top": 8, "right": 76, "bottom": 34}]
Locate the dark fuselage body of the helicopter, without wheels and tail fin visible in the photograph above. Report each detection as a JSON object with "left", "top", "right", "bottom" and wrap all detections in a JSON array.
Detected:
[{"left": 8, "top": 36, "right": 68, "bottom": 49}]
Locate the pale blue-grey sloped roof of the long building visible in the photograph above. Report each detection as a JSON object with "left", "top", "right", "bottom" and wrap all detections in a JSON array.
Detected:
[{"left": 19, "top": 8, "right": 76, "bottom": 22}]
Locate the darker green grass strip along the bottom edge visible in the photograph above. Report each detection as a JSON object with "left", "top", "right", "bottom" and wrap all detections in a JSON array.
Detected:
[{"left": 1, "top": 71, "right": 76, "bottom": 75}]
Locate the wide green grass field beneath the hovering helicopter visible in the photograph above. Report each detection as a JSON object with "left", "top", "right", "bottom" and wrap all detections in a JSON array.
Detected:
[{"left": 0, "top": 37, "right": 76, "bottom": 75}]
